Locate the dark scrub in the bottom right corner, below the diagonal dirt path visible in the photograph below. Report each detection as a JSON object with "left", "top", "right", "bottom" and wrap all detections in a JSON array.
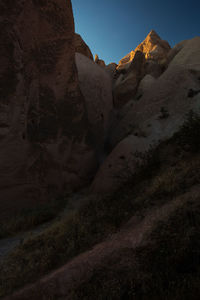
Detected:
[{"left": 71, "top": 197, "right": 200, "bottom": 300}]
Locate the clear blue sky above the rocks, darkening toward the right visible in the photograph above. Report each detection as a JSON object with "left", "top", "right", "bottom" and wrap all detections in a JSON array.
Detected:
[{"left": 71, "top": 0, "right": 200, "bottom": 64}]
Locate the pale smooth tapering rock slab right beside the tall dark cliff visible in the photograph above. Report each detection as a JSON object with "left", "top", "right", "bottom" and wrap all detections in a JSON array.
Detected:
[{"left": 76, "top": 53, "right": 113, "bottom": 161}]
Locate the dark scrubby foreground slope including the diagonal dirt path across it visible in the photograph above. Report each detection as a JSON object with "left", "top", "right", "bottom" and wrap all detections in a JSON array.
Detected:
[{"left": 0, "top": 135, "right": 200, "bottom": 300}]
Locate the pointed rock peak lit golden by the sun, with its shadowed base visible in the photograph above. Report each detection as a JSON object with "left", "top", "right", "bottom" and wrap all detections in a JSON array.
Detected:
[{"left": 113, "top": 30, "right": 171, "bottom": 108}]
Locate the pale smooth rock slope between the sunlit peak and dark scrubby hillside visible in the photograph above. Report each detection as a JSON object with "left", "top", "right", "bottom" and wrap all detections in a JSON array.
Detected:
[{"left": 93, "top": 37, "right": 200, "bottom": 192}]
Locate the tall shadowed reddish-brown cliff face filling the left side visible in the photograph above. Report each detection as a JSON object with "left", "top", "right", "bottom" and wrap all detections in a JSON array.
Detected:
[{"left": 0, "top": 0, "right": 95, "bottom": 220}]
